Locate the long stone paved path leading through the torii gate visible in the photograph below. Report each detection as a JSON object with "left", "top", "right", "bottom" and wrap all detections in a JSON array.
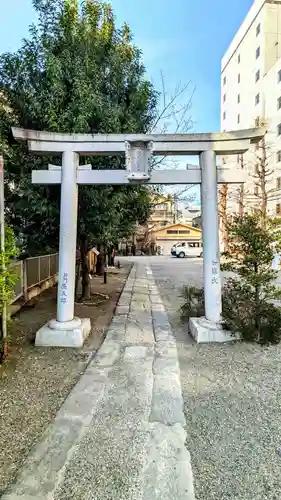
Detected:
[{"left": 2, "top": 264, "right": 194, "bottom": 500}]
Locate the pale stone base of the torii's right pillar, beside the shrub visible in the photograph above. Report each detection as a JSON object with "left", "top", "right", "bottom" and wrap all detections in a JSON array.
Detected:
[{"left": 189, "top": 317, "right": 239, "bottom": 344}]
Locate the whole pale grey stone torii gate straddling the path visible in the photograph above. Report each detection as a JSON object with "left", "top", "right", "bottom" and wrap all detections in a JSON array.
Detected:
[{"left": 13, "top": 128, "right": 265, "bottom": 347}]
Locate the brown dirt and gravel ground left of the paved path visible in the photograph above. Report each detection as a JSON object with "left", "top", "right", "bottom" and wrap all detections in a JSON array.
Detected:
[{"left": 0, "top": 266, "right": 129, "bottom": 494}]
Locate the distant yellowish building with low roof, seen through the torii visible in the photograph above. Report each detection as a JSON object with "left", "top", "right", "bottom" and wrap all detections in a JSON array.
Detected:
[{"left": 151, "top": 224, "right": 202, "bottom": 255}]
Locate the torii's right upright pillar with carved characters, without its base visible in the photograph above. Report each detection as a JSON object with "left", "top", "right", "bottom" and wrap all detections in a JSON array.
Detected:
[{"left": 200, "top": 151, "right": 222, "bottom": 323}]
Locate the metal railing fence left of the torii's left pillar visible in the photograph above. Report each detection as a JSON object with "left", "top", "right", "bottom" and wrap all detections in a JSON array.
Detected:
[{"left": 11, "top": 253, "right": 59, "bottom": 303}]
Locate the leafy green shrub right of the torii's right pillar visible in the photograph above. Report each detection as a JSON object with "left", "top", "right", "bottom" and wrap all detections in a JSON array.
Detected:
[{"left": 222, "top": 214, "right": 281, "bottom": 344}]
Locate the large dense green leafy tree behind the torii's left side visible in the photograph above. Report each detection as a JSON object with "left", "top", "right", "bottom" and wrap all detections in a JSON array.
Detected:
[{"left": 0, "top": 0, "right": 158, "bottom": 293}]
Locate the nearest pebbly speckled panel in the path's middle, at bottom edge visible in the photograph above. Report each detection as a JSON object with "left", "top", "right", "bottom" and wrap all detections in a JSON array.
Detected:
[{"left": 54, "top": 420, "right": 153, "bottom": 500}]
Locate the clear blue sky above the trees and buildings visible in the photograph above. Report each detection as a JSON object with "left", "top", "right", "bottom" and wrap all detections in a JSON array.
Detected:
[{"left": 0, "top": 0, "right": 253, "bottom": 132}]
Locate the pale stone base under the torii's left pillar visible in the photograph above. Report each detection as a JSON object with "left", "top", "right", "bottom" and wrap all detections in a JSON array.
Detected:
[{"left": 35, "top": 318, "right": 91, "bottom": 348}]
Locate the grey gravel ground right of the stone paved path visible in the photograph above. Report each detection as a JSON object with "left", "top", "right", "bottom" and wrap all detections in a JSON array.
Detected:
[{"left": 125, "top": 257, "right": 281, "bottom": 500}]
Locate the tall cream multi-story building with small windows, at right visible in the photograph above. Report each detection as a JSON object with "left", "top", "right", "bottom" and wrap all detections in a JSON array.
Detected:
[{"left": 221, "top": 0, "right": 281, "bottom": 215}]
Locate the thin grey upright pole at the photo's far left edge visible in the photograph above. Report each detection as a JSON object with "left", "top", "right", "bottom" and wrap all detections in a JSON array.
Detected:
[{"left": 0, "top": 155, "right": 7, "bottom": 357}]
